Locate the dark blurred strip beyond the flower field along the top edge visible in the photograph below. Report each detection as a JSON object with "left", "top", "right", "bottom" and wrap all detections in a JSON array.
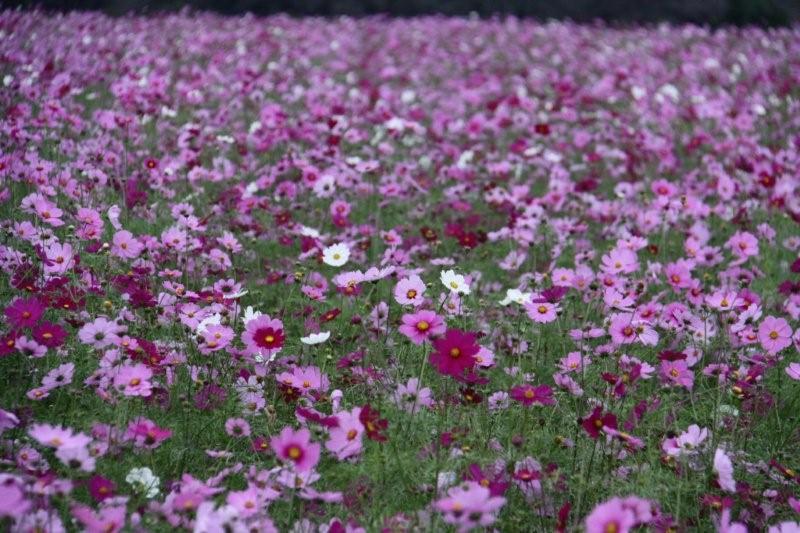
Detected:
[{"left": 5, "top": 0, "right": 800, "bottom": 26}]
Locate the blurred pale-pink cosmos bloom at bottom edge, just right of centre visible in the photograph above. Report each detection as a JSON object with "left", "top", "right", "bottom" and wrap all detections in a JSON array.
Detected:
[{"left": 434, "top": 481, "right": 506, "bottom": 532}]
